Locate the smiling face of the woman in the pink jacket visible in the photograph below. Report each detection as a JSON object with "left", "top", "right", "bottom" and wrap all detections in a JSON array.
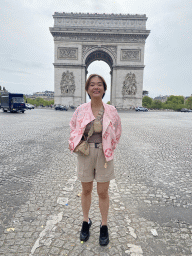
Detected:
[{"left": 87, "top": 76, "right": 105, "bottom": 99}]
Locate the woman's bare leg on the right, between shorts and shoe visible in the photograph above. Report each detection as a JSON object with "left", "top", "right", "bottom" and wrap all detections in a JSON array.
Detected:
[{"left": 97, "top": 181, "right": 109, "bottom": 226}]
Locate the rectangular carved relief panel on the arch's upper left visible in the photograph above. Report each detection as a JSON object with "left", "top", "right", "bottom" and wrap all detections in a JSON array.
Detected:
[{"left": 57, "top": 47, "right": 78, "bottom": 60}]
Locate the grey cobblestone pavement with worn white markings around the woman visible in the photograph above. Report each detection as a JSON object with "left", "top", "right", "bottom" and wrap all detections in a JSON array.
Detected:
[{"left": 0, "top": 109, "right": 192, "bottom": 256}]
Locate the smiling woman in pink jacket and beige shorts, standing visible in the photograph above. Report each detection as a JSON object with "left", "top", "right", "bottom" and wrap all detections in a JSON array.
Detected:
[{"left": 69, "top": 74, "right": 121, "bottom": 245}]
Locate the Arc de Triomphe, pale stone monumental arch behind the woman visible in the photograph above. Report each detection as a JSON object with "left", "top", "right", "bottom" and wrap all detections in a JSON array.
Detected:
[{"left": 50, "top": 12, "right": 150, "bottom": 108}]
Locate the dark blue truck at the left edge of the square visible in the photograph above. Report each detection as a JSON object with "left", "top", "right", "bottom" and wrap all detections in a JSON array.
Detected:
[{"left": 0, "top": 92, "right": 26, "bottom": 113}]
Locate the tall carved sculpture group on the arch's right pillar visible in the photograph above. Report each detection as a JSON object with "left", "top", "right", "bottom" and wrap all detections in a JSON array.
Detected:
[{"left": 122, "top": 72, "right": 137, "bottom": 97}]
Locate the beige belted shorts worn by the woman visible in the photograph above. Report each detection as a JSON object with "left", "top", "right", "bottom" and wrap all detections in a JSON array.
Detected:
[{"left": 77, "top": 143, "right": 115, "bottom": 182}]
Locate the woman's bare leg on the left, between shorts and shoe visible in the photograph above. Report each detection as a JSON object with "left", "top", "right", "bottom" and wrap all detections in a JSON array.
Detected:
[{"left": 81, "top": 181, "right": 93, "bottom": 222}]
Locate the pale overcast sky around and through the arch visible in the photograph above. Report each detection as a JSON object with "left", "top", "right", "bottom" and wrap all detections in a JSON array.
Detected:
[{"left": 0, "top": 0, "right": 192, "bottom": 102}]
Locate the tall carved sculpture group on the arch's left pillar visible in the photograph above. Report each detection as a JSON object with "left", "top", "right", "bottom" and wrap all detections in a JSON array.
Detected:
[{"left": 60, "top": 70, "right": 75, "bottom": 96}]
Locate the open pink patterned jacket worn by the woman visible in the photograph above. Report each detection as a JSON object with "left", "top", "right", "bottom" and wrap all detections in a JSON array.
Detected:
[{"left": 69, "top": 102, "right": 121, "bottom": 161}]
